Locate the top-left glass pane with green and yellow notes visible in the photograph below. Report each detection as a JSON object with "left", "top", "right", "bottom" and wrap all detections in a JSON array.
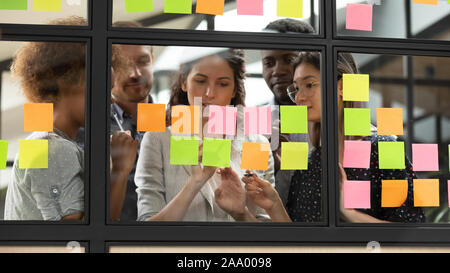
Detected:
[{"left": 0, "top": 0, "right": 88, "bottom": 26}]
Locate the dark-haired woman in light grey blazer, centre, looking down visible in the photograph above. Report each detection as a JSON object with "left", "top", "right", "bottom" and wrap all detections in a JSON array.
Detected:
[{"left": 135, "top": 49, "right": 274, "bottom": 221}]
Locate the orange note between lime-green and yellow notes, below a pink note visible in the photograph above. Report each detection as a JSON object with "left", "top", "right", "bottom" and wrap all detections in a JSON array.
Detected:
[{"left": 241, "top": 142, "right": 270, "bottom": 170}]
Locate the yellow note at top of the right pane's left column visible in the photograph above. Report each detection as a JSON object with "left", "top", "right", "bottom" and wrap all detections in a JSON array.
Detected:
[{"left": 342, "top": 74, "right": 369, "bottom": 101}]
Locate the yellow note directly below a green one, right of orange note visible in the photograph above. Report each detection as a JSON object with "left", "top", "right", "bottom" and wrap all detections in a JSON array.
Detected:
[{"left": 280, "top": 142, "right": 309, "bottom": 170}]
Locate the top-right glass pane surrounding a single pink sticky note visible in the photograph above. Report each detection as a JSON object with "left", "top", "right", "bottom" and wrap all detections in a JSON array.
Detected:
[{"left": 335, "top": 0, "right": 450, "bottom": 41}]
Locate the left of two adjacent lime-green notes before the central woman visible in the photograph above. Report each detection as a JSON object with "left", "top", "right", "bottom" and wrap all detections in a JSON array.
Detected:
[{"left": 170, "top": 136, "right": 199, "bottom": 165}]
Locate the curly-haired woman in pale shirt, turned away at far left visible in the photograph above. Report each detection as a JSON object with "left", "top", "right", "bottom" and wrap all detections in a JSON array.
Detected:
[{"left": 4, "top": 17, "right": 137, "bottom": 221}]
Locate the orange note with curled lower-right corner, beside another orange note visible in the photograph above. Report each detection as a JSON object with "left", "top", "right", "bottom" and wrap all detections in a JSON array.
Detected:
[{"left": 381, "top": 180, "right": 408, "bottom": 208}]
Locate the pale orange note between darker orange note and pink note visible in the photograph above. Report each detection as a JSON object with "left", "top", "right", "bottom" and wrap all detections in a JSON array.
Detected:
[{"left": 171, "top": 105, "right": 201, "bottom": 134}]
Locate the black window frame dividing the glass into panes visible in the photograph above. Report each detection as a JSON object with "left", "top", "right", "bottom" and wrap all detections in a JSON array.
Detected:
[{"left": 0, "top": 0, "right": 450, "bottom": 253}]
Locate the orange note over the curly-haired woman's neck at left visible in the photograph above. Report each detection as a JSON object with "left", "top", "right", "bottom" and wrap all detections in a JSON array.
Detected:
[{"left": 23, "top": 103, "right": 53, "bottom": 132}]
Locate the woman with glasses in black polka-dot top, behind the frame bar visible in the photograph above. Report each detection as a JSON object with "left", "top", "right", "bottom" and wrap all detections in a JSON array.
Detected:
[{"left": 237, "top": 52, "right": 425, "bottom": 223}]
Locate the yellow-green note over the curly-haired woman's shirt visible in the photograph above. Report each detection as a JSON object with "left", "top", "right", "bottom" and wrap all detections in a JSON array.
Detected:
[{"left": 19, "top": 139, "right": 48, "bottom": 169}]
